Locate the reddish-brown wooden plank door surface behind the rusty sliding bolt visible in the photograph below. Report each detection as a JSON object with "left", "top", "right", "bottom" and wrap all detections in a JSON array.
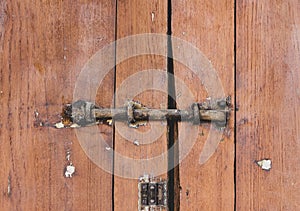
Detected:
[{"left": 0, "top": 0, "right": 300, "bottom": 211}]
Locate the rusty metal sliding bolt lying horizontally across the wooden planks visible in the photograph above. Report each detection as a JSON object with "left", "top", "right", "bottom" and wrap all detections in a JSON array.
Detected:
[{"left": 55, "top": 97, "right": 231, "bottom": 128}]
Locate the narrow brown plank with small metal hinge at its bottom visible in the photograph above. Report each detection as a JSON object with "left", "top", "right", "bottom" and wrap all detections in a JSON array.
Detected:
[{"left": 114, "top": 0, "right": 167, "bottom": 211}]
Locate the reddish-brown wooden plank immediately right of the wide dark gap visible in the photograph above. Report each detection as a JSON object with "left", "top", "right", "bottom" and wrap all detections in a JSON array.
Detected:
[{"left": 172, "top": 0, "right": 234, "bottom": 210}]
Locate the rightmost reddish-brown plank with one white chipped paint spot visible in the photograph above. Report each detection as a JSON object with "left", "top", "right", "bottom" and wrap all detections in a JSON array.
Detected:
[{"left": 236, "top": 0, "right": 300, "bottom": 210}]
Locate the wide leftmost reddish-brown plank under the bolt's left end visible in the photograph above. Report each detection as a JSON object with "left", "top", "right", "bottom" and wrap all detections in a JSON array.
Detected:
[{"left": 0, "top": 0, "right": 115, "bottom": 210}]
